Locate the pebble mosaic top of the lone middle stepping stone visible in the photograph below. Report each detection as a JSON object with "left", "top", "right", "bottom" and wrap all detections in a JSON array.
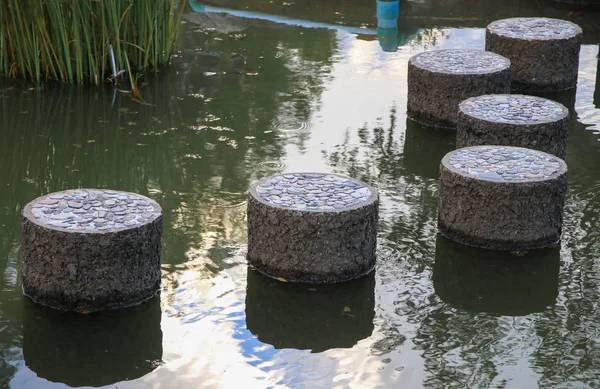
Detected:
[{"left": 256, "top": 173, "right": 371, "bottom": 211}]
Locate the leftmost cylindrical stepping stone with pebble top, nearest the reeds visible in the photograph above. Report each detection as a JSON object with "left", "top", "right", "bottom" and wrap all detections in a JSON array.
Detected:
[{"left": 21, "top": 189, "right": 162, "bottom": 312}]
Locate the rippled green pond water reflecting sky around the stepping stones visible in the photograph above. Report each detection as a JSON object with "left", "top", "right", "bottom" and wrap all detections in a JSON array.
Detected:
[{"left": 0, "top": 0, "right": 600, "bottom": 389}]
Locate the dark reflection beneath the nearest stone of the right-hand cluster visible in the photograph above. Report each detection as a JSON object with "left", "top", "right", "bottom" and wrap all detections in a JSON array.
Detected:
[{"left": 433, "top": 235, "right": 560, "bottom": 316}]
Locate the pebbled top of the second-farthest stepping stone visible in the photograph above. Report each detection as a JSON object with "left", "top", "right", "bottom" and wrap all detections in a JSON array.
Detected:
[{"left": 412, "top": 50, "right": 510, "bottom": 73}]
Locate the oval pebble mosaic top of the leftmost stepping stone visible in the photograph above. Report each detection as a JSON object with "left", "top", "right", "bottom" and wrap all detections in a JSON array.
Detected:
[{"left": 31, "top": 189, "right": 155, "bottom": 232}]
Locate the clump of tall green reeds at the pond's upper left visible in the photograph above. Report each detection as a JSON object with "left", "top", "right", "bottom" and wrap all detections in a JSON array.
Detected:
[{"left": 0, "top": 0, "right": 188, "bottom": 86}]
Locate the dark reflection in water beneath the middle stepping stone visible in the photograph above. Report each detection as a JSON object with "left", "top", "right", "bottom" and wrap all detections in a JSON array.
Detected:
[{"left": 246, "top": 269, "right": 375, "bottom": 353}]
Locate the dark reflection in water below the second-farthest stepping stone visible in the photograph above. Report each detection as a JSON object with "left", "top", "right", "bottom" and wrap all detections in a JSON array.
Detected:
[{"left": 403, "top": 119, "right": 456, "bottom": 178}]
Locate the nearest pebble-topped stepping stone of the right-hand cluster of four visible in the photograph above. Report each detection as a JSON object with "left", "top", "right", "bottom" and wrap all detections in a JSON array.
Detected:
[{"left": 438, "top": 146, "right": 567, "bottom": 251}]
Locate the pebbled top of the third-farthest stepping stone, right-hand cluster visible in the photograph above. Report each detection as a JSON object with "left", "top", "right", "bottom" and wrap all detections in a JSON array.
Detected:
[{"left": 460, "top": 95, "right": 569, "bottom": 124}]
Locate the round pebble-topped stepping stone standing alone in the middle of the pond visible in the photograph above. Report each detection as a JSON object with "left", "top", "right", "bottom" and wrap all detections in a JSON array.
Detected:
[{"left": 247, "top": 173, "right": 379, "bottom": 283}]
